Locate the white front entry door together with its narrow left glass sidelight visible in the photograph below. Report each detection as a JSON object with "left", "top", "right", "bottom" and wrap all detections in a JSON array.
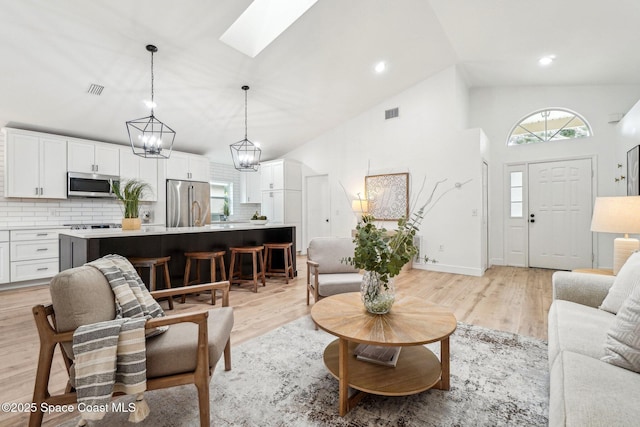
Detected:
[{"left": 505, "top": 158, "right": 593, "bottom": 270}]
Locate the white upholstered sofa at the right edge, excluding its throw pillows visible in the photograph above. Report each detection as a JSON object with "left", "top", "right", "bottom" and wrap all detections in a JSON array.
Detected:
[{"left": 549, "top": 270, "right": 640, "bottom": 427}]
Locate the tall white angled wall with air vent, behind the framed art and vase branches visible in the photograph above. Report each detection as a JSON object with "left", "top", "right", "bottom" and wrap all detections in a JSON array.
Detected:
[{"left": 286, "top": 67, "right": 484, "bottom": 275}]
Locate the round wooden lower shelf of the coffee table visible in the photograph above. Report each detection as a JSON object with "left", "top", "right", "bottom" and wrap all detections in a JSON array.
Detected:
[{"left": 324, "top": 339, "right": 442, "bottom": 400}]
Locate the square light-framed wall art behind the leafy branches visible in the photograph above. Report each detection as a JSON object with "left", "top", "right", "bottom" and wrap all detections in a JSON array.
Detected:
[{"left": 364, "top": 173, "right": 409, "bottom": 221}]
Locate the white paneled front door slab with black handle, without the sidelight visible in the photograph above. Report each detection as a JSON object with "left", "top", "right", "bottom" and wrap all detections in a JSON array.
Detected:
[{"left": 528, "top": 159, "right": 593, "bottom": 270}]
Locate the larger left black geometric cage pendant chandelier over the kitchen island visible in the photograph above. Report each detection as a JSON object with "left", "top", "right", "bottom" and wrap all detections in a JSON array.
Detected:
[{"left": 127, "top": 44, "right": 176, "bottom": 159}]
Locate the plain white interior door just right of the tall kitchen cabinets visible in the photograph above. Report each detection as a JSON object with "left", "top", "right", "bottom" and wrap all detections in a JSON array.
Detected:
[{"left": 305, "top": 175, "right": 331, "bottom": 249}]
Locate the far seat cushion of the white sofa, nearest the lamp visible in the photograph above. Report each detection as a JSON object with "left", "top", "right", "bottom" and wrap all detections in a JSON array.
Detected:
[{"left": 548, "top": 300, "right": 616, "bottom": 367}]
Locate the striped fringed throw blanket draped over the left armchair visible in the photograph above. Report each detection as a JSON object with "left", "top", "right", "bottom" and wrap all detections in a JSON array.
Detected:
[{"left": 73, "top": 255, "right": 168, "bottom": 425}]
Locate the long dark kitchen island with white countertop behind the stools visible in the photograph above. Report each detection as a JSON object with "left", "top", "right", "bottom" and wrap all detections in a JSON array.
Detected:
[{"left": 59, "top": 223, "right": 297, "bottom": 286}]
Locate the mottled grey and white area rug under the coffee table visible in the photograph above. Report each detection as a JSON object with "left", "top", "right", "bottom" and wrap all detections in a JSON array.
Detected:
[{"left": 61, "top": 316, "right": 549, "bottom": 427}]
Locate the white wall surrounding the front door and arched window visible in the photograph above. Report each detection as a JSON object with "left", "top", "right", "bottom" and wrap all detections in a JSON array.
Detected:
[{"left": 469, "top": 85, "right": 640, "bottom": 268}]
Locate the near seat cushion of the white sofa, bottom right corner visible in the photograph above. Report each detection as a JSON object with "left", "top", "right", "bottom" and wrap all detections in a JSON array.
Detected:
[{"left": 549, "top": 351, "right": 640, "bottom": 427}]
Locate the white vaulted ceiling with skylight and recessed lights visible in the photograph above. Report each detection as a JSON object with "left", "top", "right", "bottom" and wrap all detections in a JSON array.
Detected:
[{"left": 0, "top": 0, "right": 640, "bottom": 163}]
